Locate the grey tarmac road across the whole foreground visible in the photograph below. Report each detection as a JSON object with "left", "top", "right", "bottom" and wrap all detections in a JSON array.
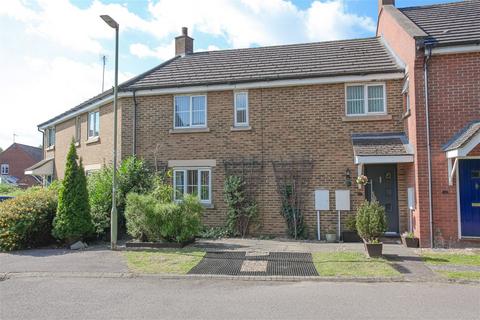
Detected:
[{"left": 0, "top": 277, "right": 480, "bottom": 320}]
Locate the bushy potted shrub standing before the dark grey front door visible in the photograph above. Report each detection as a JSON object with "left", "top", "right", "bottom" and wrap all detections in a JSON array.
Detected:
[{"left": 356, "top": 200, "right": 387, "bottom": 258}]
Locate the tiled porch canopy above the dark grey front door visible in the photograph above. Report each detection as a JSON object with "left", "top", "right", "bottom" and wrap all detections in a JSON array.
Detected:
[{"left": 352, "top": 132, "right": 413, "bottom": 164}]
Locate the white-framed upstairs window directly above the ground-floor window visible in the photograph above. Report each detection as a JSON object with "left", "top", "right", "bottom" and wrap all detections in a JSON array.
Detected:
[{"left": 173, "top": 95, "right": 207, "bottom": 128}]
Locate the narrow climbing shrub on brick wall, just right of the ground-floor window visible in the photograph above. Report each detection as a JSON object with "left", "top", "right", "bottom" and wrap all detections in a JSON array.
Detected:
[{"left": 223, "top": 176, "right": 258, "bottom": 237}]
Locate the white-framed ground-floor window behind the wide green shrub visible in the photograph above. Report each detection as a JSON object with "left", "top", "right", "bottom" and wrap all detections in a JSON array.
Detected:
[{"left": 173, "top": 168, "right": 212, "bottom": 204}]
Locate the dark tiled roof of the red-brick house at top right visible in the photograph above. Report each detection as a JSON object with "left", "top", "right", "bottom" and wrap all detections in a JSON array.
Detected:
[{"left": 399, "top": 0, "right": 480, "bottom": 46}]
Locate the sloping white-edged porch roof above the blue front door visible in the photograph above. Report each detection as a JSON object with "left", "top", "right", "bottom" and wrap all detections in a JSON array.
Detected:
[{"left": 442, "top": 120, "right": 480, "bottom": 158}]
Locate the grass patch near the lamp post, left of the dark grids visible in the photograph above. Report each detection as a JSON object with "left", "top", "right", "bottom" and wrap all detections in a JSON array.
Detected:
[{"left": 124, "top": 249, "right": 205, "bottom": 274}]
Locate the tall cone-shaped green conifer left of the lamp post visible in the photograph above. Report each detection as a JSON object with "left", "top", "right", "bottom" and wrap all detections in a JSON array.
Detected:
[{"left": 52, "top": 141, "right": 94, "bottom": 243}]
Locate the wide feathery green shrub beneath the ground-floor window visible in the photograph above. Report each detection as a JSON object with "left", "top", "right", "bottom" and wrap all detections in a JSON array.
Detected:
[{"left": 125, "top": 193, "right": 203, "bottom": 242}]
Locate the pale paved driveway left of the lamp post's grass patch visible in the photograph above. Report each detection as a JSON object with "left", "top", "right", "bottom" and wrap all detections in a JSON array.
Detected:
[{"left": 0, "top": 245, "right": 128, "bottom": 273}]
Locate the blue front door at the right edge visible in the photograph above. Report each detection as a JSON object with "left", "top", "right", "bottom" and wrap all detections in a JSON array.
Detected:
[{"left": 458, "top": 159, "right": 480, "bottom": 237}]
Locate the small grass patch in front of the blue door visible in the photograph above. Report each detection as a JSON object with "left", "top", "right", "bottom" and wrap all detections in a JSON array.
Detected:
[{"left": 421, "top": 251, "right": 480, "bottom": 280}]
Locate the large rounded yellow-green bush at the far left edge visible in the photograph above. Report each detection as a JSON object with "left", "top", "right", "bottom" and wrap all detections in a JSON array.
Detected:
[{"left": 0, "top": 188, "right": 57, "bottom": 251}]
